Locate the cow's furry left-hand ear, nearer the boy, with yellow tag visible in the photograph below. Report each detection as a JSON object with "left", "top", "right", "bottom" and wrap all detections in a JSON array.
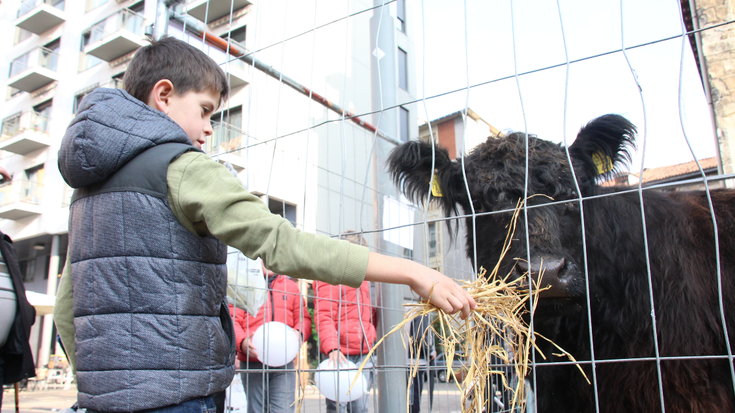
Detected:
[{"left": 388, "top": 141, "right": 467, "bottom": 214}]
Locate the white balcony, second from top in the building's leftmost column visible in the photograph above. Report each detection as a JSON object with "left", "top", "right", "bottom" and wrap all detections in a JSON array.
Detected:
[{"left": 8, "top": 47, "right": 59, "bottom": 92}]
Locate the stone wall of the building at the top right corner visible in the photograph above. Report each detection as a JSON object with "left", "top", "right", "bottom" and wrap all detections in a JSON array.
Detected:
[{"left": 691, "top": 0, "right": 735, "bottom": 187}]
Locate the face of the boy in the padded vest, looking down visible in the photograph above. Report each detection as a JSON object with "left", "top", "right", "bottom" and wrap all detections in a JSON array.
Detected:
[{"left": 163, "top": 90, "right": 220, "bottom": 149}]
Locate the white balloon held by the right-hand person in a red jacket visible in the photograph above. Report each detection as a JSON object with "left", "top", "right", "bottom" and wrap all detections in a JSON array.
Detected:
[{"left": 314, "top": 359, "right": 368, "bottom": 402}]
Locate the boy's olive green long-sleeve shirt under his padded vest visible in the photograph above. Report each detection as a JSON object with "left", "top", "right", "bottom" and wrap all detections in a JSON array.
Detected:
[{"left": 54, "top": 152, "right": 368, "bottom": 368}]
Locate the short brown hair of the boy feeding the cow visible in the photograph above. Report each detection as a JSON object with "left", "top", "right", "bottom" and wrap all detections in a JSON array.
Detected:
[{"left": 123, "top": 37, "right": 230, "bottom": 103}]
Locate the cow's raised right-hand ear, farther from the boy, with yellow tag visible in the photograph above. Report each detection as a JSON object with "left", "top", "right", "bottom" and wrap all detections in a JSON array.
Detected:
[{"left": 569, "top": 115, "right": 636, "bottom": 183}]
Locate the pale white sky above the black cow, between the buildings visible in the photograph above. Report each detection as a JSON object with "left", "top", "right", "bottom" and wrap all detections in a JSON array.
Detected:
[{"left": 408, "top": 0, "right": 716, "bottom": 172}]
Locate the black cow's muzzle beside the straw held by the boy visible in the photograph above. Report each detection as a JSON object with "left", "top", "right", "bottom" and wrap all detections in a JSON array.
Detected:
[{"left": 514, "top": 255, "right": 579, "bottom": 298}]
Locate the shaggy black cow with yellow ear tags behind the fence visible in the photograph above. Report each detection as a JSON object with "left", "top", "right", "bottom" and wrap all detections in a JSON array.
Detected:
[{"left": 388, "top": 115, "right": 735, "bottom": 413}]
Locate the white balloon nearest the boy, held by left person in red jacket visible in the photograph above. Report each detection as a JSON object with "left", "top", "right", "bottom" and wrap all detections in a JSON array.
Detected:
[{"left": 253, "top": 321, "right": 299, "bottom": 367}]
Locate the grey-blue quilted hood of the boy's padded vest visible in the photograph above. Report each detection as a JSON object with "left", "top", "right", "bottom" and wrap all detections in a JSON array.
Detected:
[{"left": 59, "top": 88, "right": 191, "bottom": 188}]
